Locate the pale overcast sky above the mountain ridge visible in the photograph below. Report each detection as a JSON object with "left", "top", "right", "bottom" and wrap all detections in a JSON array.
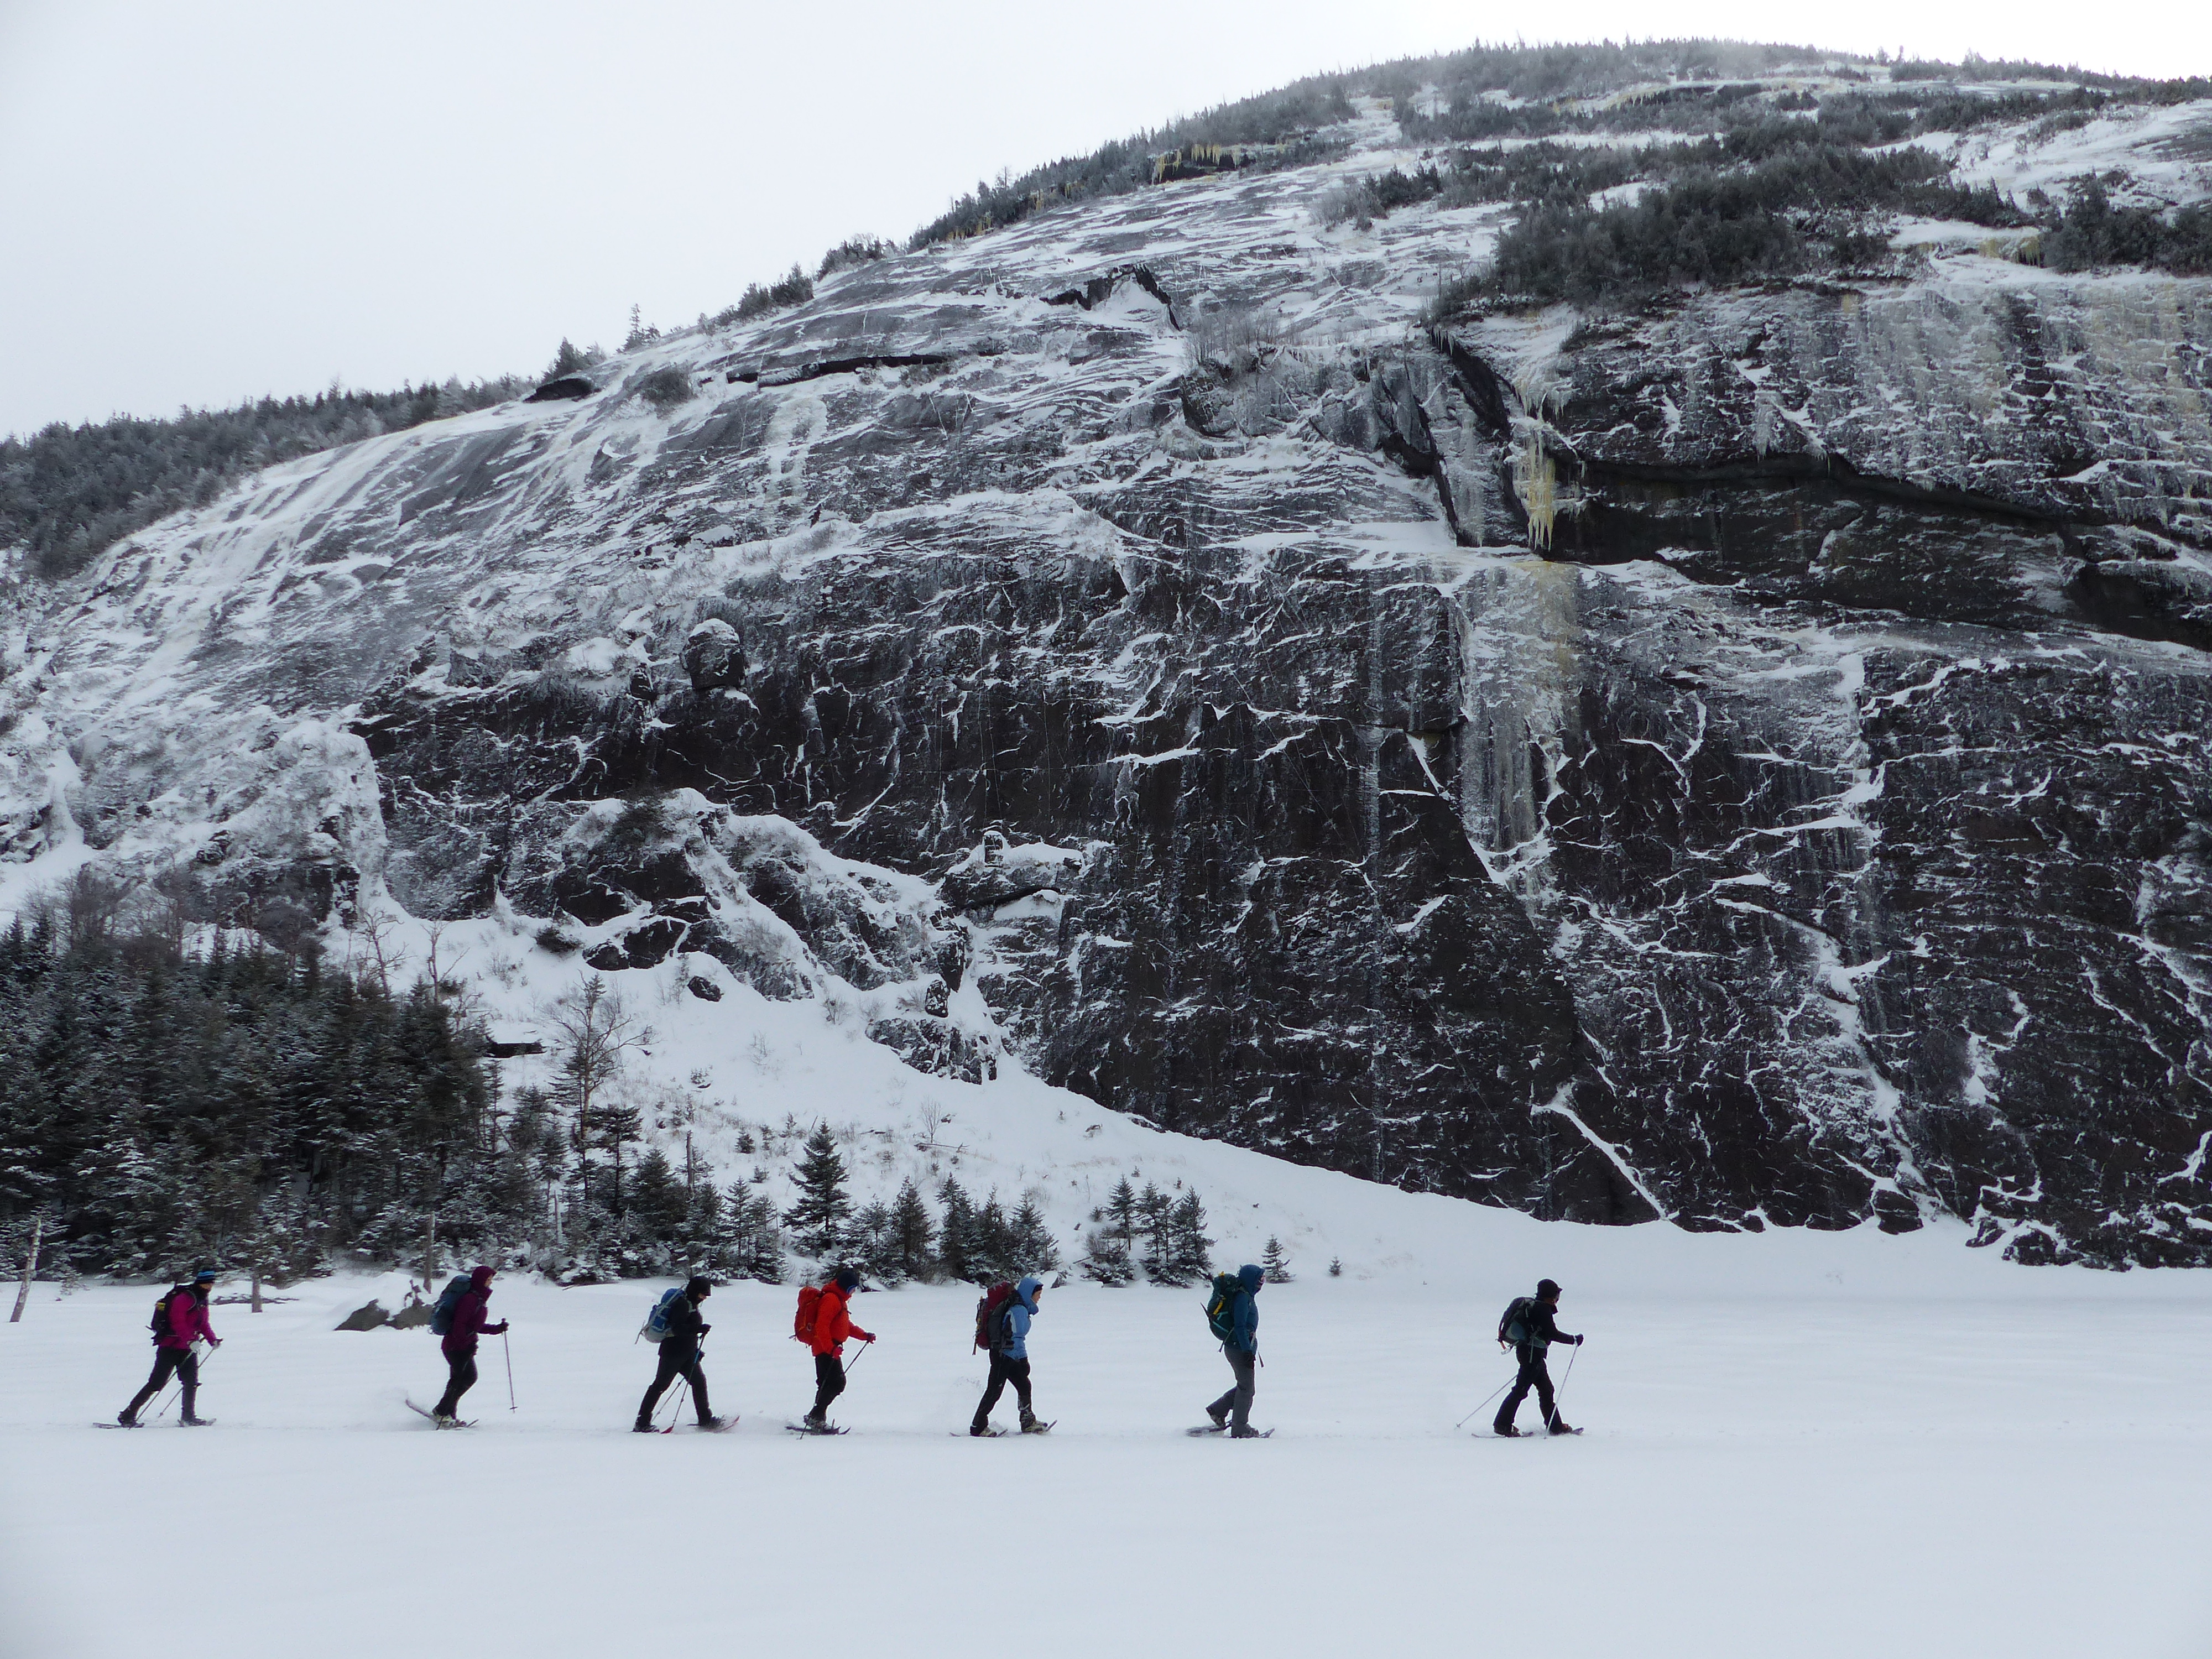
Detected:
[{"left": 0, "top": 0, "right": 2212, "bottom": 431}]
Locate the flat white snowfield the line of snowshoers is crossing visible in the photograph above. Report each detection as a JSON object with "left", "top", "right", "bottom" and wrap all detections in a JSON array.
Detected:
[{"left": 0, "top": 1221, "right": 2212, "bottom": 1659}]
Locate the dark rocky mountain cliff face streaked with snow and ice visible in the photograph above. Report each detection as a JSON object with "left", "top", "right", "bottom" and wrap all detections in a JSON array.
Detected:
[{"left": 0, "top": 52, "right": 2212, "bottom": 1263}]
